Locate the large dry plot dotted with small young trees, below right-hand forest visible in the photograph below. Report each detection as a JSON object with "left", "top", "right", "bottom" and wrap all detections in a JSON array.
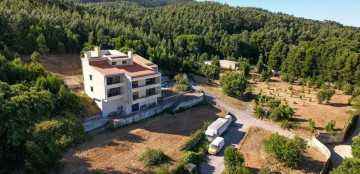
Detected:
[{"left": 251, "top": 77, "right": 351, "bottom": 135}]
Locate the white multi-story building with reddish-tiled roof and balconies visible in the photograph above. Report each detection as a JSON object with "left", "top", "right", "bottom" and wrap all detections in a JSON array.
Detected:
[{"left": 81, "top": 47, "right": 161, "bottom": 117}]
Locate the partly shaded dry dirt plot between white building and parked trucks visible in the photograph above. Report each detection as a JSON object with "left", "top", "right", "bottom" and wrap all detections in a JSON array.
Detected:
[{"left": 62, "top": 105, "right": 226, "bottom": 173}]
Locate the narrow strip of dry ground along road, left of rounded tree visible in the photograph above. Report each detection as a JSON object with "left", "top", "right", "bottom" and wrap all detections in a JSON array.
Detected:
[{"left": 192, "top": 74, "right": 246, "bottom": 110}]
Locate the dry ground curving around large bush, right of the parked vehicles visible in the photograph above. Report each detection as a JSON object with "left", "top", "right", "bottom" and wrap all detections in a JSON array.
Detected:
[{"left": 239, "top": 127, "right": 326, "bottom": 173}]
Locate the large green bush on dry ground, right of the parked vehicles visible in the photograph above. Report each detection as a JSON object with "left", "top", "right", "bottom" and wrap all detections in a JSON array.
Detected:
[{"left": 263, "top": 134, "right": 307, "bottom": 167}]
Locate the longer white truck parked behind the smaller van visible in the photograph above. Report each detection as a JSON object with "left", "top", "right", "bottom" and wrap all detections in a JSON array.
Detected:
[{"left": 205, "top": 115, "right": 232, "bottom": 141}]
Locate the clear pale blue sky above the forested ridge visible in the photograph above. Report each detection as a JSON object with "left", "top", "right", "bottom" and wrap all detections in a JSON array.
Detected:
[{"left": 198, "top": 0, "right": 360, "bottom": 27}]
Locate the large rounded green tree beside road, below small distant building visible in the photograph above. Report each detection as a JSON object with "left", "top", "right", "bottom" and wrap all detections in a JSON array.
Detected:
[{"left": 220, "top": 72, "right": 249, "bottom": 98}]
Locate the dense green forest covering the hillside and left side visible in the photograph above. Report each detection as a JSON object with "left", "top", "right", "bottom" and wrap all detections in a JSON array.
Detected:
[{"left": 0, "top": 0, "right": 360, "bottom": 173}]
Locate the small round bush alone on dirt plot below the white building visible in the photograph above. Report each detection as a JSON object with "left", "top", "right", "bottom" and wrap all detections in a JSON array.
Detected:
[{"left": 140, "top": 148, "right": 166, "bottom": 167}]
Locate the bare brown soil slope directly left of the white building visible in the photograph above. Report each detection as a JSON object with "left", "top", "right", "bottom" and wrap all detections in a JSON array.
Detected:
[{"left": 39, "top": 54, "right": 82, "bottom": 75}]
